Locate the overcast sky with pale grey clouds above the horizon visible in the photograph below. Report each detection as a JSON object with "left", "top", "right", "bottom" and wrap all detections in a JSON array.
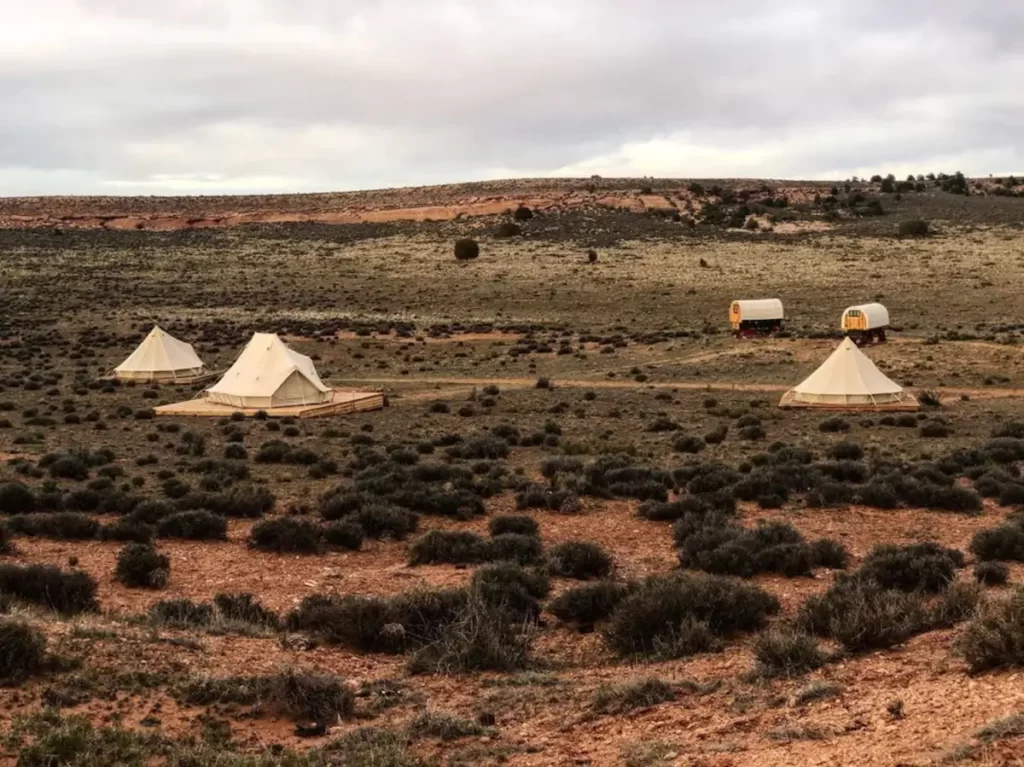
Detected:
[{"left": 0, "top": 0, "right": 1024, "bottom": 196}]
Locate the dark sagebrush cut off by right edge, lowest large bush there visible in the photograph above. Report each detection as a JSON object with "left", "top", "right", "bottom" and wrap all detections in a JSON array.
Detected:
[{"left": 957, "top": 587, "right": 1024, "bottom": 672}]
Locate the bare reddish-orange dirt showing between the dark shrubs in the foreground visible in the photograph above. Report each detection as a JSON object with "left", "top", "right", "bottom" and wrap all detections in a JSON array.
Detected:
[{"left": 0, "top": 497, "right": 1024, "bottom": 766}]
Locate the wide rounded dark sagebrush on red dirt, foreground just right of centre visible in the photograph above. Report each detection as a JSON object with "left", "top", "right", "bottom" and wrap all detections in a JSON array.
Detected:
[{"left": 604, "top": 573, "right": 779, "bottom": 657}]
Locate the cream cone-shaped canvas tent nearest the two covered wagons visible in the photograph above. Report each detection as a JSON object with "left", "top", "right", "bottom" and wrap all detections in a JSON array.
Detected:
[{"left": 779, "top": 338, "right": 918, "bottom": 410}]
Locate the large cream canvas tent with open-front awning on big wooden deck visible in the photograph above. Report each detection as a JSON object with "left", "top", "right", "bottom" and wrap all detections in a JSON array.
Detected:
[{"left": 205, "top": 333, "right": 332, "bottom": 410}]
